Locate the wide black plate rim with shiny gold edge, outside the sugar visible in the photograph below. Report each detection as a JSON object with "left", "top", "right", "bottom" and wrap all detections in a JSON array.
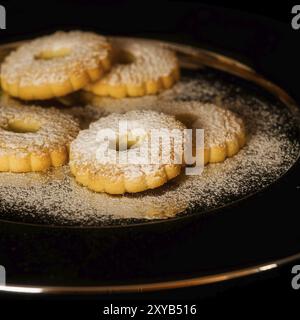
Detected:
[{"left": 0, "top": 36, "right": 300, "bottom": 293}]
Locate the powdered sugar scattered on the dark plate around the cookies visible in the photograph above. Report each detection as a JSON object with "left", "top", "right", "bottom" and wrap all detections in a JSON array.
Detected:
[{"left": 0, "top": 70, "right": 300, "bottom": 226}]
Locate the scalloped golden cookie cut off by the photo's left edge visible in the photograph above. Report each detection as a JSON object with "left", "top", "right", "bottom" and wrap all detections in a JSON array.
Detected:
[{"left": 0, "top": 97, "right": 79, "bottom": 172}]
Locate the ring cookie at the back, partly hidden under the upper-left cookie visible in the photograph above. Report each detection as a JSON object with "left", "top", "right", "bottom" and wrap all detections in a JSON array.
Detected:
[{"left": 85, "top": 40, "right": 179, "bottom": 98}]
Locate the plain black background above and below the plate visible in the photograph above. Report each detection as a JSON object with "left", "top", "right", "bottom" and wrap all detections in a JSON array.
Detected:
[{"left": 0, "top": 0, "right": 300, "bottom": 319}]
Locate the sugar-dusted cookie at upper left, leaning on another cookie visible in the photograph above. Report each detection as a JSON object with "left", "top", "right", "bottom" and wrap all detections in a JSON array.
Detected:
[{"left": 1, "top": 31, "right": 111, "bottom": 100}]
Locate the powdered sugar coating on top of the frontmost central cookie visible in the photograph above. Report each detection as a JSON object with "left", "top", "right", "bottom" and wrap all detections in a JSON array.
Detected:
[{"left": 70, "top": 110, "right": 185, "bottom": 180}]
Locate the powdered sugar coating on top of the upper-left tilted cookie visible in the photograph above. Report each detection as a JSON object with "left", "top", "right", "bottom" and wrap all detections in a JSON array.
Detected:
[{"left": 1, "top": 31, "right": 111, "bottom": 87}]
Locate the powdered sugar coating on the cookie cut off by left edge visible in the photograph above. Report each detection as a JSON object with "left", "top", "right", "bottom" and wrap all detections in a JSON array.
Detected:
[{"left": 0, "top": 95, "right": 79, "bottom": 156}]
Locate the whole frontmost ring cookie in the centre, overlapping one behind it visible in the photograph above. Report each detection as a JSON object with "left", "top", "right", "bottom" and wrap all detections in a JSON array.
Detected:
[{"left": 70, "top": 111, "right": 185, "bottom": 194}]
